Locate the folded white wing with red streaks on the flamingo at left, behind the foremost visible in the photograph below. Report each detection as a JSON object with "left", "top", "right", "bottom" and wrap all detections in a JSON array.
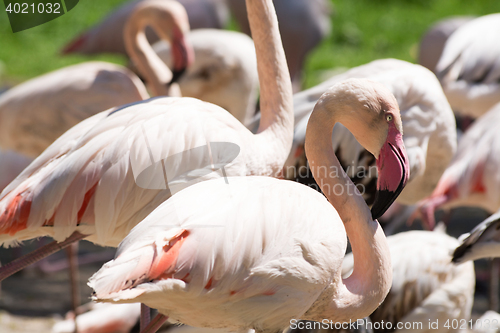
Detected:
[{"left": 0, "top": 98, "right": 250, "bottom": 246}]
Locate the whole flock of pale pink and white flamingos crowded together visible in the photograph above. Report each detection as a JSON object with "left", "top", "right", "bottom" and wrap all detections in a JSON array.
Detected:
[{"left": 0, "top": 0, "right": 500, "bottom": 333}]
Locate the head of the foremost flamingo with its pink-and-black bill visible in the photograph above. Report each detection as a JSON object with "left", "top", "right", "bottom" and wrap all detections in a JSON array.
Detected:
[{"left": 328, "top": 79, "right": 410, "bottom": 219}]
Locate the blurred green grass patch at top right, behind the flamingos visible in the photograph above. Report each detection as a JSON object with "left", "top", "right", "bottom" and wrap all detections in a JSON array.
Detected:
[{"left": 305, "top": 0, "right": 500, "bottom": 87}]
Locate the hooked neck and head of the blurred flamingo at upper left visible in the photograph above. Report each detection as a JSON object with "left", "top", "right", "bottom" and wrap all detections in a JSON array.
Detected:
[{"left": 123, "top": 6, "right": 188, "bottom": 96}]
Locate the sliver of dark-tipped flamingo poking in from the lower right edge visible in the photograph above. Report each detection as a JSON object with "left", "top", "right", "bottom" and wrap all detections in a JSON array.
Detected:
[{"left": 453, "top": 210, "right": 500, "bottom": 264}]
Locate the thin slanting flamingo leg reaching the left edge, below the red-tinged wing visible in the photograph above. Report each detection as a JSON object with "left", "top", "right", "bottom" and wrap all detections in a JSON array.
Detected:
[{"left": 0, "top": 231, "right": 88, "bottom": 281}]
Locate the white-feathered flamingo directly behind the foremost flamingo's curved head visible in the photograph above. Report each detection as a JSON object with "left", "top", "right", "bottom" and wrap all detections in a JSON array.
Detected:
[{"left": 250, "top": 59, "right": 457, "bottom": 205}]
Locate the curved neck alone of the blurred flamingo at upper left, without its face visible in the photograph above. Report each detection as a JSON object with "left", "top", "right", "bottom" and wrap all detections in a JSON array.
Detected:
[{"left": 123, "top": 12, "right": 179, "bottom": 96}]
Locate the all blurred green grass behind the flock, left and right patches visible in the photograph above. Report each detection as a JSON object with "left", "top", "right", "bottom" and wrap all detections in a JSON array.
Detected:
[{"left": 0, "top": 0, "right": 500, "bottom": 86}]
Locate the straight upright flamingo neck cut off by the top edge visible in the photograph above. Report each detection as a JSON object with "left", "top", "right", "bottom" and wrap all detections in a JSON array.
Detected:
[{"left": 246, "top": 0, "right": 294, "bottom": 169}]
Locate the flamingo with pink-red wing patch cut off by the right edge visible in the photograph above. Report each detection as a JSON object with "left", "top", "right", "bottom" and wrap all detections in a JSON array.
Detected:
[{"left": 415, "top": 104, "right": 500, "bottom": 229}]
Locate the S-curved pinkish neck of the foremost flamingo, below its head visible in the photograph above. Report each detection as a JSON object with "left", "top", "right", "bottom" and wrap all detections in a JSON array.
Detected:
[{"left": 304, "top": 104, "right": 392, "bottom": 321}]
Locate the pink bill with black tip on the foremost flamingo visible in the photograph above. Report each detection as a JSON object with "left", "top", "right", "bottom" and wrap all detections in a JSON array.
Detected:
[{"left": 371, "top": 128, "right": 410, "bottom": 220}]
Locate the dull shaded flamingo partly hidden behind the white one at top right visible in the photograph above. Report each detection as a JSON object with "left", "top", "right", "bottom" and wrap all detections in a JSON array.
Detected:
[{"left": 418, "top": 16, "right": 474, "bottom": 72}]
